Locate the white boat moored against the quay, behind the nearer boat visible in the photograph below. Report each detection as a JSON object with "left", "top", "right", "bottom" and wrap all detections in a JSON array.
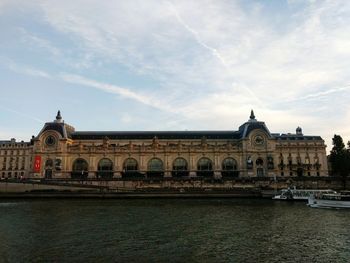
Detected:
[{"left": 272, "top": 188, "right": 336, "bottom": 201}]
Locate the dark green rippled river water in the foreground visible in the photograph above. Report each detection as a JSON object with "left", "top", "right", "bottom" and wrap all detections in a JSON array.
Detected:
[{"left": 0, "top": 199, "right": 350, "bottom": 263}]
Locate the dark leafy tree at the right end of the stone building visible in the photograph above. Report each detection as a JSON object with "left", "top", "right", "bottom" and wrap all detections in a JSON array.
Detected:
[{"left": 329, "top": 134, "right": 350, "bottom": 187}]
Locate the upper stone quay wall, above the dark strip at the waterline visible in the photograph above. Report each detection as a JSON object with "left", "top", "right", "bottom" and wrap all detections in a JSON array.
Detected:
[{"left": 0, "top": 177, "right": 350, "bottom": 195}]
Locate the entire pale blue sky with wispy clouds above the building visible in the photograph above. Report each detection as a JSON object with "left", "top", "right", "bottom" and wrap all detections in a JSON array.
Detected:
[{"left": 0, "top": 0, "right": 350, "bottom": 151}]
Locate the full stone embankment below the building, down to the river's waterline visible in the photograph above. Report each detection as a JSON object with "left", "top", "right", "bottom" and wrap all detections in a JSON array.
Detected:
[{"left": 0, "top": 177, "right": 350, "bottom": 198}]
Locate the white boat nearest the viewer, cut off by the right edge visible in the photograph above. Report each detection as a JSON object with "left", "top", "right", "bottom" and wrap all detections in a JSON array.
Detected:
[{"left": 307, "top": 192, "right": 350, "bottom": 208}]
